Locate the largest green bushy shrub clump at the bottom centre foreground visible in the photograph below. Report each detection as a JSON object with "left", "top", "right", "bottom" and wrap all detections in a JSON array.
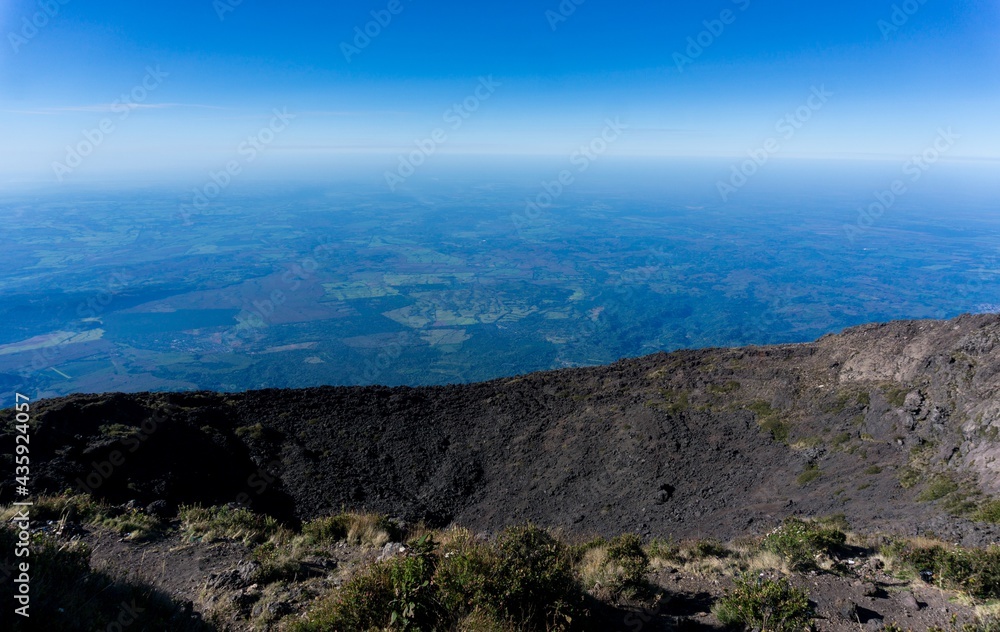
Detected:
[{"left": 291, "top": 526, "right": 586, "bottom": 632}]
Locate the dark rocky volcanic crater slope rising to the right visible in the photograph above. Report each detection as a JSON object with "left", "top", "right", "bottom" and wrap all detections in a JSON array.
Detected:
[{"left": 0, "top": 315, "right": 1000, "bottom": 541}]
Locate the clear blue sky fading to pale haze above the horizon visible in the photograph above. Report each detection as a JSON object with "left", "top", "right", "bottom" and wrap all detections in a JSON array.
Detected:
[{"left": 0, "top": 0, "right": 1000, "bottom": 182}]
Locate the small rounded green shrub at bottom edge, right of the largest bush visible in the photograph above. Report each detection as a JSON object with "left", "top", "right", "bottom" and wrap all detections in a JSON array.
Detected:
[{"left": 715, "top": 575, "right": 813, "bottom": 632}]
